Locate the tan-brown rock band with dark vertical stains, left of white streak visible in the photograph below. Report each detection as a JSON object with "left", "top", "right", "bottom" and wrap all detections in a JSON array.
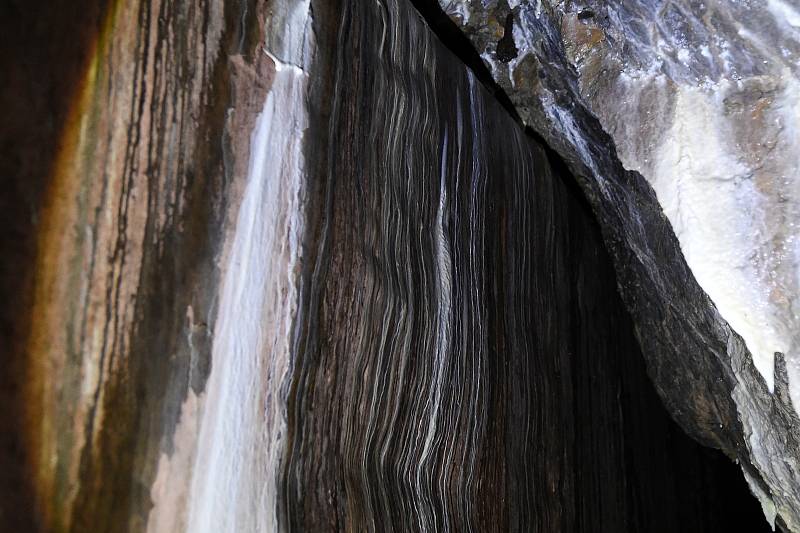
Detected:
[{"left": 9, "top": 1, "right": 270, "bottom": 531}]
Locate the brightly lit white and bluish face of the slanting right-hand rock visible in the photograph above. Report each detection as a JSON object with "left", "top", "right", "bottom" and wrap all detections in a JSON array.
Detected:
[{"left": 564, "top": 0, "right": 800, "bottom": 409}]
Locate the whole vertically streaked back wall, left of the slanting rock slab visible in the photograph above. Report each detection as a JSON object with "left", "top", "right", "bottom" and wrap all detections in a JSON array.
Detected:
[{"left": 0, "top": 0, "right": 788, "bottom": 533}]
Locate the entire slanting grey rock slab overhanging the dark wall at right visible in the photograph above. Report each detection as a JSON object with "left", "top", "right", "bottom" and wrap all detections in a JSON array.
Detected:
[{"left": 439, "top": 0, "right": 800, "bottom": 530}]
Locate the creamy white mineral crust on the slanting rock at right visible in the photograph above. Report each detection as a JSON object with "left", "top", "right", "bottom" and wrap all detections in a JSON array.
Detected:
[{"left": 648, "top": 77, "right": 800, "bottom": 396}]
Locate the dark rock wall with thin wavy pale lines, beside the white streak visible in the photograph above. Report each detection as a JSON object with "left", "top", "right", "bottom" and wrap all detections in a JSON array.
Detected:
[{"left": 276, "top": 2, "right": 757, "bottom": 531}]
